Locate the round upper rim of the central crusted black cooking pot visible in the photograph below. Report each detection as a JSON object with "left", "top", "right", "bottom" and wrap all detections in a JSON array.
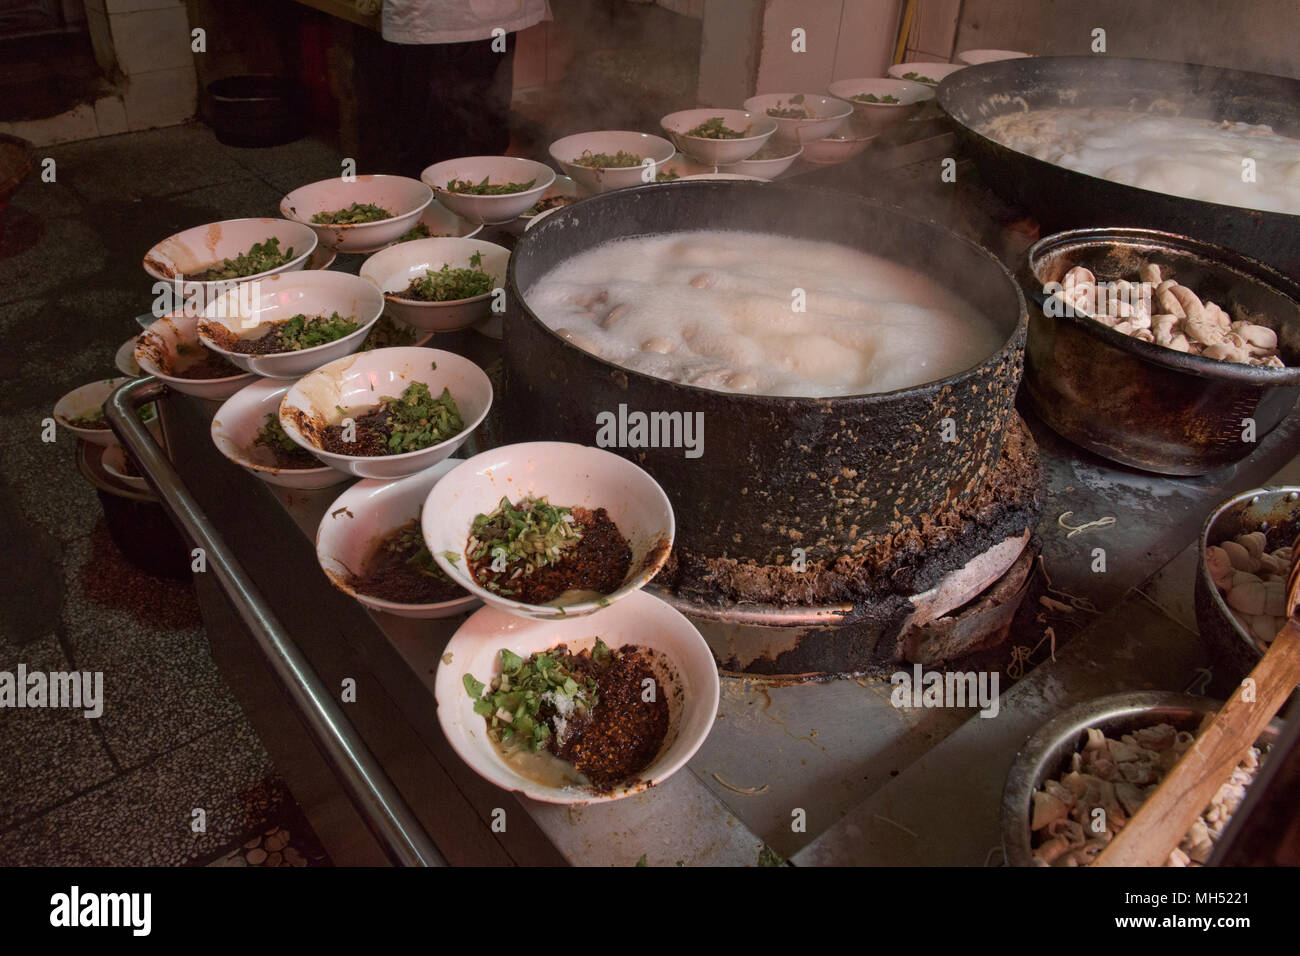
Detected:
[{"left": 506, "top": 179, "right": 1030, "bottom": 410}]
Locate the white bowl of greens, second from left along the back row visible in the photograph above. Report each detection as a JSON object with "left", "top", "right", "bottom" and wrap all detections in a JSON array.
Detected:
[{"left": 280, "top": 176, "right": 433, "bottom": 252}]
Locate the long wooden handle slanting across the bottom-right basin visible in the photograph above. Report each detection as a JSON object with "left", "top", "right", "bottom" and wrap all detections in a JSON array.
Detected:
[{"left": 1092, "top": 617, "right": 1300, "bottom": 866}]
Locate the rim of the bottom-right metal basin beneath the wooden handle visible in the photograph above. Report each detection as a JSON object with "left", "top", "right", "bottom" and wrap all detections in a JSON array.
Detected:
[{"left": 1000, "top": 691, "right": 1282, "bottom": 866}]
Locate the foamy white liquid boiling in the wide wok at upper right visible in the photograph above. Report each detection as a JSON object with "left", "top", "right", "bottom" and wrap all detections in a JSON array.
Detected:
[{"left": 979, "top": 109, "right": 1300, "bottom": 215}]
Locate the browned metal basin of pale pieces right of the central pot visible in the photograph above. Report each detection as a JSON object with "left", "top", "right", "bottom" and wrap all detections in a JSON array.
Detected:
[{"left": 1024, "top": 228, "right": 1300, "bottom": 475}]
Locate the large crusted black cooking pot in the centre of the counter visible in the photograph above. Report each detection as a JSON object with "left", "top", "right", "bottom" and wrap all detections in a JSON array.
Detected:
[{"left": 504, "top": 181, "right": 1026, "bottom": 564}]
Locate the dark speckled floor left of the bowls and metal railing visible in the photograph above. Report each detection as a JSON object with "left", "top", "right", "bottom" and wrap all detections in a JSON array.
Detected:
[{"left": 0, "top": 124, "right": 339, "bottom": 865}]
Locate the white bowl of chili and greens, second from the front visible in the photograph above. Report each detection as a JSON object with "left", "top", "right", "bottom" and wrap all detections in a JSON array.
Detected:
[{"left": 421, "top": 441, "right": 673, "bottom": 620}]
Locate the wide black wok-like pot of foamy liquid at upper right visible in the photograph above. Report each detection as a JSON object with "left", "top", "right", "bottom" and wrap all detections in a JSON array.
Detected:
[{"left": 939, "top": 56, "right": 1300, "bottom": 276}]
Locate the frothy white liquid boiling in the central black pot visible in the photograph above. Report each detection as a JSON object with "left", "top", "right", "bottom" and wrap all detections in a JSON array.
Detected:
[{"left": 525, "top": 231, "right": 1004, "bottom": 397}]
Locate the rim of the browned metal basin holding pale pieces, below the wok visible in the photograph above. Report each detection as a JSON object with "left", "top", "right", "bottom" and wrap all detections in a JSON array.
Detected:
[{"left": 1026, "top": 226, "right": 1300, "bottom": 386}]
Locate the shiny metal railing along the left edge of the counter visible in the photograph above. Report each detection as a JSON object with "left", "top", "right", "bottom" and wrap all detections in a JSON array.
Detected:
[{"left": 104, "top": 377, "right": 446, "bottom": 866}]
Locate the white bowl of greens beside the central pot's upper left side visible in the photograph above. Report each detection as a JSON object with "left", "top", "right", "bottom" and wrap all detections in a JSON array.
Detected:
[{"left": 361, "top": 239, "right": 510, "bottom": 332}]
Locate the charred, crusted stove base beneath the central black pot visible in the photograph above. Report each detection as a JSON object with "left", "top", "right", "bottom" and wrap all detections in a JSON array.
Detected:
[{"left": 651, "top": 416, "right": 1041, "bottom": 680}]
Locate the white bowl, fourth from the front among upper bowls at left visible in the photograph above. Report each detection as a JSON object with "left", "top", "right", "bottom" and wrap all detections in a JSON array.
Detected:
[{"left": 199, "top": 272, "right": 384, "bottom": 378}]
